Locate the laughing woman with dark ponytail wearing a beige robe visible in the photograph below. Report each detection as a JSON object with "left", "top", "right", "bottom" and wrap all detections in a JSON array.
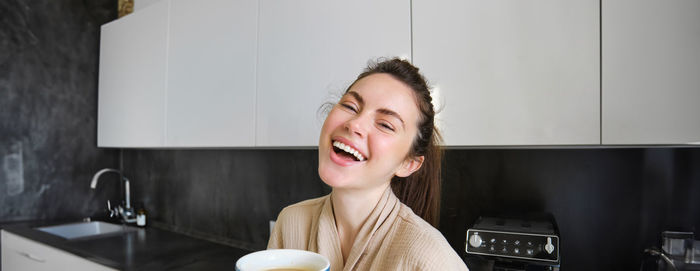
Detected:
[{"left": 268, "top": 59, "right": 467, "bottom": 270}]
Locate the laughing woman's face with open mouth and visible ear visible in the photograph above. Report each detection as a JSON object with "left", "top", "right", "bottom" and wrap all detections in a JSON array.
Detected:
[{"left": 318, "top": 73, "right": 423, "bottom": 189}]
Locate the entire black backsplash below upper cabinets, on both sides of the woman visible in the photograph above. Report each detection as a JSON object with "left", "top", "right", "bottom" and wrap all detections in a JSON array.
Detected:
[{"left": 124, "top": 148, "right": 700, "bottom": 270}]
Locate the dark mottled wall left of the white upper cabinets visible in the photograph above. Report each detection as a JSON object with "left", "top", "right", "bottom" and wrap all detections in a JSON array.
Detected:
[{"left": 0, "top": 0, "right": 119, "bottom": 222}]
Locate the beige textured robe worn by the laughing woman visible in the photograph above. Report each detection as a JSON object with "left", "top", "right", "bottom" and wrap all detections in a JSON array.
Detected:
[{"left": 267, "top": 189, "right": 467, "bottom": 271}]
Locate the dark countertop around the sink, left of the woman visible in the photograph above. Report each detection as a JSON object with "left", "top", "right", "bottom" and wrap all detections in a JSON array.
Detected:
[{"left": 0, "top": 222, "right": 251, "bottom": 270}]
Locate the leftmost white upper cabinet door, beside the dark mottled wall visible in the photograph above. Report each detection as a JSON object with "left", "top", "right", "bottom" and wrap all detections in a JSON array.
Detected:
[{"left": 97, "top": 1, "right": 169, "bottom": 147}]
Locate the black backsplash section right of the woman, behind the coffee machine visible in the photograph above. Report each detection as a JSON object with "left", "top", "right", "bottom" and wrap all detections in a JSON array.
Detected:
[{"left": 440, "top": 148, "right": 700, "bottom": 270}]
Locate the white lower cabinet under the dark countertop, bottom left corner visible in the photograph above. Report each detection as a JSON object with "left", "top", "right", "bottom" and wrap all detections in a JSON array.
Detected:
[{"left": 1, "top": 230, "right": 115, "bottom": 271}]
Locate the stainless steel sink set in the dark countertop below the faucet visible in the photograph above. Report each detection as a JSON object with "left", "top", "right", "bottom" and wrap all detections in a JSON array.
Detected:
[{"left": 36, "top": 221, "right": 136, "bottom": 239}]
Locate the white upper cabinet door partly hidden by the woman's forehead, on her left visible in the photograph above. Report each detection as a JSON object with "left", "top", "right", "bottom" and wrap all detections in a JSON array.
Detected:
[{"left": 256, "top": 0, "right": 411, "bottom": 147}]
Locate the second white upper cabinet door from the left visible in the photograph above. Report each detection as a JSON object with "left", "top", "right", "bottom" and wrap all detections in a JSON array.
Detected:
[{"left": 165, "top": 0, "right": 258, "bottom": 147}]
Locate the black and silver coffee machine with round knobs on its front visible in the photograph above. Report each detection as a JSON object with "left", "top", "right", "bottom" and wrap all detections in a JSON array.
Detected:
[{"left": 465, "top": 213, "right": 561, "bottom": 271}]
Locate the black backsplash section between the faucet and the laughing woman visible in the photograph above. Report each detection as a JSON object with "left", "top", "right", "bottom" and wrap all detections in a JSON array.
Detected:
[{"left": 124, "top": 150, "right": 330, "bottom": 250}]
